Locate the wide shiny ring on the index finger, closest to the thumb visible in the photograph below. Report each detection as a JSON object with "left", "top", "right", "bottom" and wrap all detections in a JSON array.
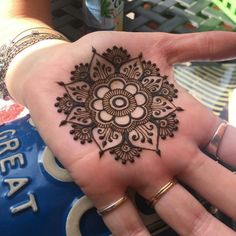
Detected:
[{"left": 206, "top": 120, "right": 228, "bottom": 161}]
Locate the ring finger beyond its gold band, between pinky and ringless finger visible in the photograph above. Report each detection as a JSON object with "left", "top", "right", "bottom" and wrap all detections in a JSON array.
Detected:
[{"left": 155, "top": 184, "right": 235, "bottom": 236}]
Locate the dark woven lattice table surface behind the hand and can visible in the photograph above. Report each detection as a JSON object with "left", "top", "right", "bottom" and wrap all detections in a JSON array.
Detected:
[{"left": 52, "top": 0, "right": 236, "bottom": 40}]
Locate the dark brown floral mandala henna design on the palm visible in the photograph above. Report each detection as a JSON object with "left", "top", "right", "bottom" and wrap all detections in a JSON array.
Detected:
[{"left": 55, "top": 46, "right": 183, "bottom": 164}]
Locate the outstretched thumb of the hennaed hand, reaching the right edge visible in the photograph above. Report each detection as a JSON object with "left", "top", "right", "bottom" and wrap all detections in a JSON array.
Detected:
[{"left": 167, "top": 31, "right": 236, "bottom": 64}]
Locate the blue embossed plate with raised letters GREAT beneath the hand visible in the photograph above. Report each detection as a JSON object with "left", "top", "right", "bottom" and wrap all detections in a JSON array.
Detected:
[{"left": 0, "top": 115, "right": 176, "bottom": 236}]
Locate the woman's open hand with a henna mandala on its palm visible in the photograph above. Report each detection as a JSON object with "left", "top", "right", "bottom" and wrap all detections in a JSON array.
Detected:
[{"left": 7, "top": 32, "right": 236, "bottom": 236}]
